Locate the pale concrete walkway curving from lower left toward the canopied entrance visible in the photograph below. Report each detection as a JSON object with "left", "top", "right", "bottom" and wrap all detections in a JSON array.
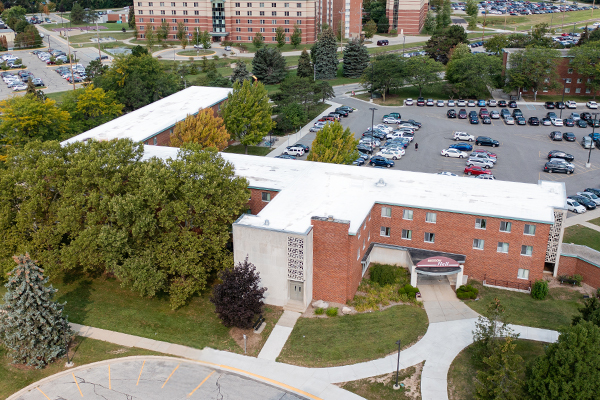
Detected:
[{"left": 9, "top": 294, "right": 558, "bottom": 400}]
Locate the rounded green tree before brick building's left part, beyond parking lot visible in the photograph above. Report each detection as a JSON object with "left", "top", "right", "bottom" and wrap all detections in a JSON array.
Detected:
[{"left": 506, "top": 47, "right": 560, "bottom": 99}]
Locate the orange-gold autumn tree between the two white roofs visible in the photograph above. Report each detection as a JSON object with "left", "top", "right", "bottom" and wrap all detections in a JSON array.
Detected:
[{"left": 170, "top": 108, "right": 229, "bottom": 151}]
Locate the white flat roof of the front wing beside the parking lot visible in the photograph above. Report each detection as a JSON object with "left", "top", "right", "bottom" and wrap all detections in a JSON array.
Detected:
[{"left": 144, "top": 146, "right": 566, "bottom": 234}]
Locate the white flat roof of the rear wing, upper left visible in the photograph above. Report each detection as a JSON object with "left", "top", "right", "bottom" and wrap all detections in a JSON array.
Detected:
[{"left": 62, "top": 86, "right": 233, "bottom": 143}]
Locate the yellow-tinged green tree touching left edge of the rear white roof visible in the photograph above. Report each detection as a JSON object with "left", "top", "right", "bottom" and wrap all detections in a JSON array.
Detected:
[{"left": 60, "top": 84, "right": 124, "bottom": 134}]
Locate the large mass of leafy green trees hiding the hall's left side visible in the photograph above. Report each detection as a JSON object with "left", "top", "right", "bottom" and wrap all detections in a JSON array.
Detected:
[{"left": 0, "top": 140, "right": 249, "bottom": 308}]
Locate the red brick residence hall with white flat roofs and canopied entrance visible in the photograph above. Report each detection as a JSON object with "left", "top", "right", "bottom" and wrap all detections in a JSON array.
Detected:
[{"left": 68, "top": 87, "right": 580, "bottom": 310}]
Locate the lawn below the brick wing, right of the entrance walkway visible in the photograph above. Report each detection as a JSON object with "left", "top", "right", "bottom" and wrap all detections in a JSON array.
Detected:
[{"left": 465, "top": 281, "right": 582, "bottom": 330}]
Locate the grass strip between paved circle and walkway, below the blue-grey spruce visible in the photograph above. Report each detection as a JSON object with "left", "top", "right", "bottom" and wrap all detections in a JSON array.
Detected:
[{"left": 0, "top": 336, "right": 164, "bottom": 399}]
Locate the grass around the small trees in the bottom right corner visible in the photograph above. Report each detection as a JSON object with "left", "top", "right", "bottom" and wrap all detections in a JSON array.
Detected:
[{"left": 448, "top": 339, "right": 547, "bottom": 400}]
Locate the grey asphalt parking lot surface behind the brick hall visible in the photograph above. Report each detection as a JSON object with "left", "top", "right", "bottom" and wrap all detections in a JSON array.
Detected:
[{"left": 298, "top": 95, "right": 600, "bottom": 200}]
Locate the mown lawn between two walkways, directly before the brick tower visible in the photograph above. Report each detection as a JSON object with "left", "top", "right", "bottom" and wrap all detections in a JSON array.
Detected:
[{"left": 277, "top": 305, "right": 428, "bottom": 367}]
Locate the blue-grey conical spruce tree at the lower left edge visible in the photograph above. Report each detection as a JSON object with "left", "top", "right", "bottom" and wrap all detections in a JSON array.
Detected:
[{"left": 0, "top": 254, "right": 73, "bottom": 368}]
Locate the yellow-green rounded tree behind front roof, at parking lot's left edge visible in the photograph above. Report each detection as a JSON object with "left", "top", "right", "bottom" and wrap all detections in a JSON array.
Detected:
[{"left": 308, "top": 122, "right": 358, "bottom": 165}]
